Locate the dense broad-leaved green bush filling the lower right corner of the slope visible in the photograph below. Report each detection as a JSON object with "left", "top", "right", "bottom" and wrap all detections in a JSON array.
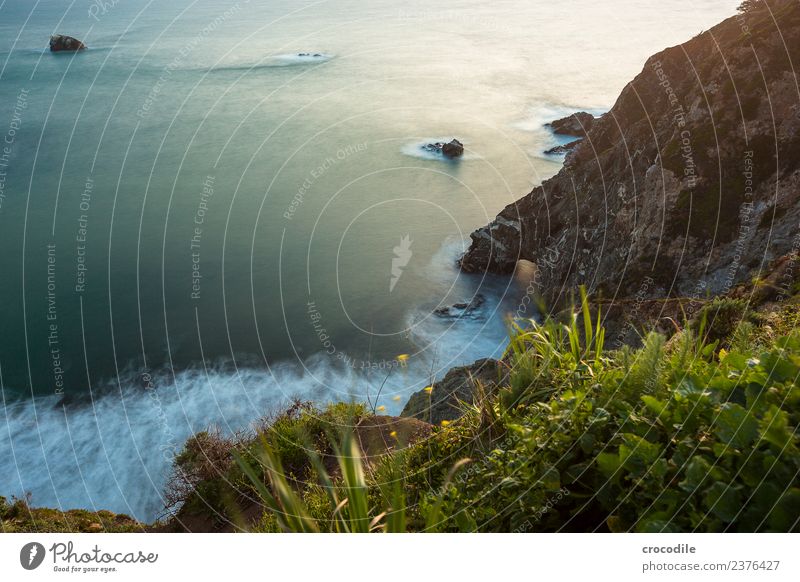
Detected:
[{"left": 406, "top": 334, "right": 800, "bottom": 532}]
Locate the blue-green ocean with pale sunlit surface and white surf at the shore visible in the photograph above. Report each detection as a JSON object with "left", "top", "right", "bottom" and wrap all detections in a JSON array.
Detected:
[{"left": 0, "top": 0, "right": 738, "bottom": 520}]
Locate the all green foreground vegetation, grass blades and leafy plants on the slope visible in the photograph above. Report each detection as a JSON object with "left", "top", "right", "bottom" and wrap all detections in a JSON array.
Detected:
[{"left": 169, "top": 296, "right": 800, "bottom": 532}]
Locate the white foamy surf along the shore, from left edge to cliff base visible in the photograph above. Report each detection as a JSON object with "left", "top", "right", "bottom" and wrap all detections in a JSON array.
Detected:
[{"left": 0, "top": 239, "right": 505, "bottom": 521}]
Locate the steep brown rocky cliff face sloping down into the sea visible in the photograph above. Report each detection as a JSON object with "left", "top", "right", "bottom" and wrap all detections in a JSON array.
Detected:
[{"left": 461, "top": 0, "right": 800, "bottom": 301}]
